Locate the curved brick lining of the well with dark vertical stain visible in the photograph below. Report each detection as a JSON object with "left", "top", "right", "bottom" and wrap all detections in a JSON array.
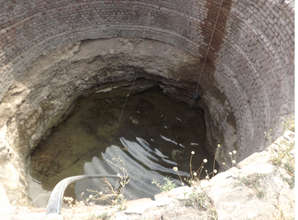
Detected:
[{"left": 0, "top": 0, "right": 294, "bottom": 158}]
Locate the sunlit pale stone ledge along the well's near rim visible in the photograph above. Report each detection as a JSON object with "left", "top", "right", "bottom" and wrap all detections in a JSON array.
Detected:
[{"left": 0, "top": 128, "right": 295, "bottom": 220}]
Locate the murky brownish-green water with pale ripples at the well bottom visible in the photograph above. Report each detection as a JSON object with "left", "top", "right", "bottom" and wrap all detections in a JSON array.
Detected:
[{"left": 29, "top": 88, "right": 213, "bottom": 206}]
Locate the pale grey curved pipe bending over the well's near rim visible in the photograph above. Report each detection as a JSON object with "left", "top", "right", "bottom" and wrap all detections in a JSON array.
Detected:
[{"left": 46, "top": 175, "right": 121, "bottom": 215}]
